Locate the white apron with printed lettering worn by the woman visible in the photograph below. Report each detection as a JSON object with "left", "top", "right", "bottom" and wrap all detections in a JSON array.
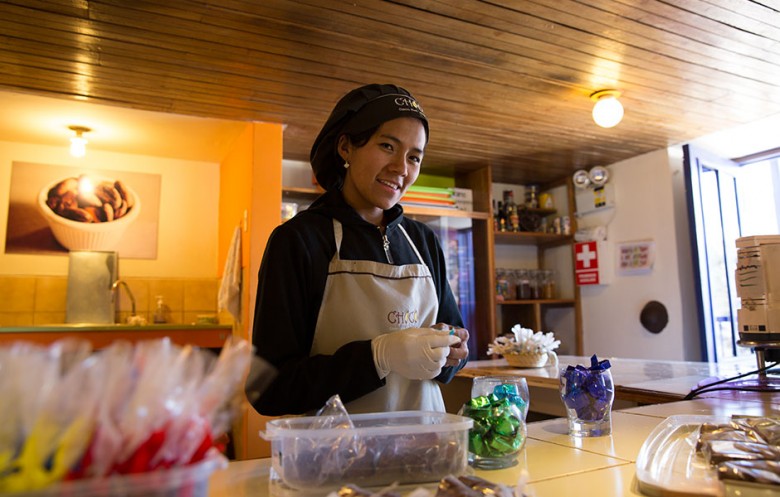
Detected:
[{"left": 310, "top": 219, "right": 445, "bottom": 414}]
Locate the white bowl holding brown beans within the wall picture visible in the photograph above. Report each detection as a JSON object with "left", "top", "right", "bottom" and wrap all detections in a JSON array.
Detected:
[{"left": 38, "top": 175, "right": 141, "bottom": 250}]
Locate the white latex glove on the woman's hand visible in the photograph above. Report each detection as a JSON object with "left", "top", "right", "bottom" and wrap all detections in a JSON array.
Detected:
[{"left": 371, "top": 328, "right": 460, "bottom": 380}]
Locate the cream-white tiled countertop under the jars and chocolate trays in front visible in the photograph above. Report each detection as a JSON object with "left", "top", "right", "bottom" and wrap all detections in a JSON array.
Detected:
[{"left": 209, "top": 393, "right": 780, "bottom": 497}]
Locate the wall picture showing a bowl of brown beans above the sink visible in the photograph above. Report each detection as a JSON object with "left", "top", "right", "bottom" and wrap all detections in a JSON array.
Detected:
[{"left": 5, "top": 161, "right": 161, "bottom": 259}]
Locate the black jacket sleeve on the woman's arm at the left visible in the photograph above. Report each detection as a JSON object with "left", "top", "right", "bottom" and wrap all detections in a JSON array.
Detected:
[{"left": 252, "top": 220, "right": 384, "bottom": 416}]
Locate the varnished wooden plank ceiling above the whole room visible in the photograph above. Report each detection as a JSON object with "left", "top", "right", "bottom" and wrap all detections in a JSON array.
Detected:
[{"left": 0, "top": 0, "right": 780, "bottom": 182}]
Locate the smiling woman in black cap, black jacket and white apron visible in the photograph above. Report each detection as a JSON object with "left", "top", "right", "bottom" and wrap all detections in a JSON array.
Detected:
[{"left": 247, "top": 85, "right": 469, "bottom": 415}]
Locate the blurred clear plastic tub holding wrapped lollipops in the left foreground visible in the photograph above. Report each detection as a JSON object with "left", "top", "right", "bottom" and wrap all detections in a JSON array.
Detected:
[{"left": 3, "top": 451, "right": 227, "bottom": 497}]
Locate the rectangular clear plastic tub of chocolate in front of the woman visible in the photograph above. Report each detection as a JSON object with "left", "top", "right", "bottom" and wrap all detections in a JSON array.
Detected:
[{"left": 260, "top": 411, "right": 473, "bottom": 490}]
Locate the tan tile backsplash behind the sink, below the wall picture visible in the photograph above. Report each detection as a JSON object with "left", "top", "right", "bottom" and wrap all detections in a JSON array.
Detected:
[{"left": 0, "top": 276, "right": 221, "bottom": 327}]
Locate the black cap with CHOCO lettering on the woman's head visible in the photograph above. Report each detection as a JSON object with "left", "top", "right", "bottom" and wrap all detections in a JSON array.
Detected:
[{"left": 309, "top": 84, "right": 428, "bottom": 190}]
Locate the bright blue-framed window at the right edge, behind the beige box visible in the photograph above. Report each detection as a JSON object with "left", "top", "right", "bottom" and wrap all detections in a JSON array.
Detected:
[{"left": 683, "top": 145, "right": 780, "bottom": 362}]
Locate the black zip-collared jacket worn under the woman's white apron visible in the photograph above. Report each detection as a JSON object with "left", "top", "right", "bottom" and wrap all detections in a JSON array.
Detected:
[{"left": 252, "top": 191, "right": 465, "bottom": 416}]
